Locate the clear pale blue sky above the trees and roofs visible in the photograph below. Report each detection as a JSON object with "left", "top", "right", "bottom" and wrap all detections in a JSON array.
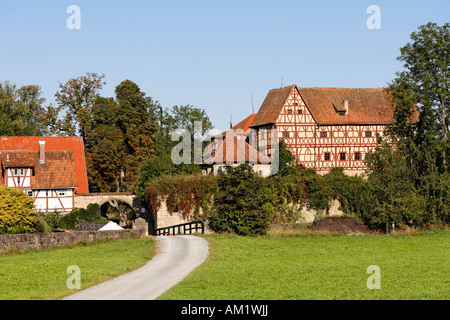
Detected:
[{"left": 0, "top": 0, "right": 450, "bottom": 130}]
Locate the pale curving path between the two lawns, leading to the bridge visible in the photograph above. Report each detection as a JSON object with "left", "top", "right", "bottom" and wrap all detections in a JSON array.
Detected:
[{"left": 64, "top": 235, "right": 208, "bottom": 300}]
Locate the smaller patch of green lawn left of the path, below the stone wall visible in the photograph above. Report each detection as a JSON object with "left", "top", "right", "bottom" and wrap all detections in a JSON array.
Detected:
[{"left": 0, "top": 238, "right": 155, "bottom": 300}]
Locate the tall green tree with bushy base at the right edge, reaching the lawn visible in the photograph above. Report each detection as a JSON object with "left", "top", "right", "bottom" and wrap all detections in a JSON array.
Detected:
[{"left": 366, "top": 23, "right": 450, "bottom": 230}]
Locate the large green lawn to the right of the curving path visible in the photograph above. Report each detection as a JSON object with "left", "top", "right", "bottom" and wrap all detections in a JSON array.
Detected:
[{"left": 160, "top": 231, "right": 450, "bottom": 300}]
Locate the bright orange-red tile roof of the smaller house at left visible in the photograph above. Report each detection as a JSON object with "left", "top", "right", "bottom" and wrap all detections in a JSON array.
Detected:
[{"left": 0, "top": 137, "right": 89, "bottom": 193}]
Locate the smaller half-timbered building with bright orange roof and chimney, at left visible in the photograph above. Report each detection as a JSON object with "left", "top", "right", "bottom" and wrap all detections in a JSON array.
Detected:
[{"left": 0, "top": 137, "right": 88, "bottom": 213}]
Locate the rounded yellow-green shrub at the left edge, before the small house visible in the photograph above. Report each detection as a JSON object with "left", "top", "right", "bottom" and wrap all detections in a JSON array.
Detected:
[{"left": 0, "top": 187, "right": 37, "bottom": 234}]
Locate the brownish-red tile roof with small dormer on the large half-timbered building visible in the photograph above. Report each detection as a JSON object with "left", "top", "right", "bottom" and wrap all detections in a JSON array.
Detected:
[{"left": 252, "top": 85, "right": 393, "bottom": 127}]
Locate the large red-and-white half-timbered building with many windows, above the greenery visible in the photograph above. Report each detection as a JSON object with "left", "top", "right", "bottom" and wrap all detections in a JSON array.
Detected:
[{"left": 251, "top": 85, "right": 393, "bottom": 174}]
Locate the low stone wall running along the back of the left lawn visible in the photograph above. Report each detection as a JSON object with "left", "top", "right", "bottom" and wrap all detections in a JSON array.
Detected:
[{"left": 0, "top": 229, "right": 146, "bottom": 251}]
